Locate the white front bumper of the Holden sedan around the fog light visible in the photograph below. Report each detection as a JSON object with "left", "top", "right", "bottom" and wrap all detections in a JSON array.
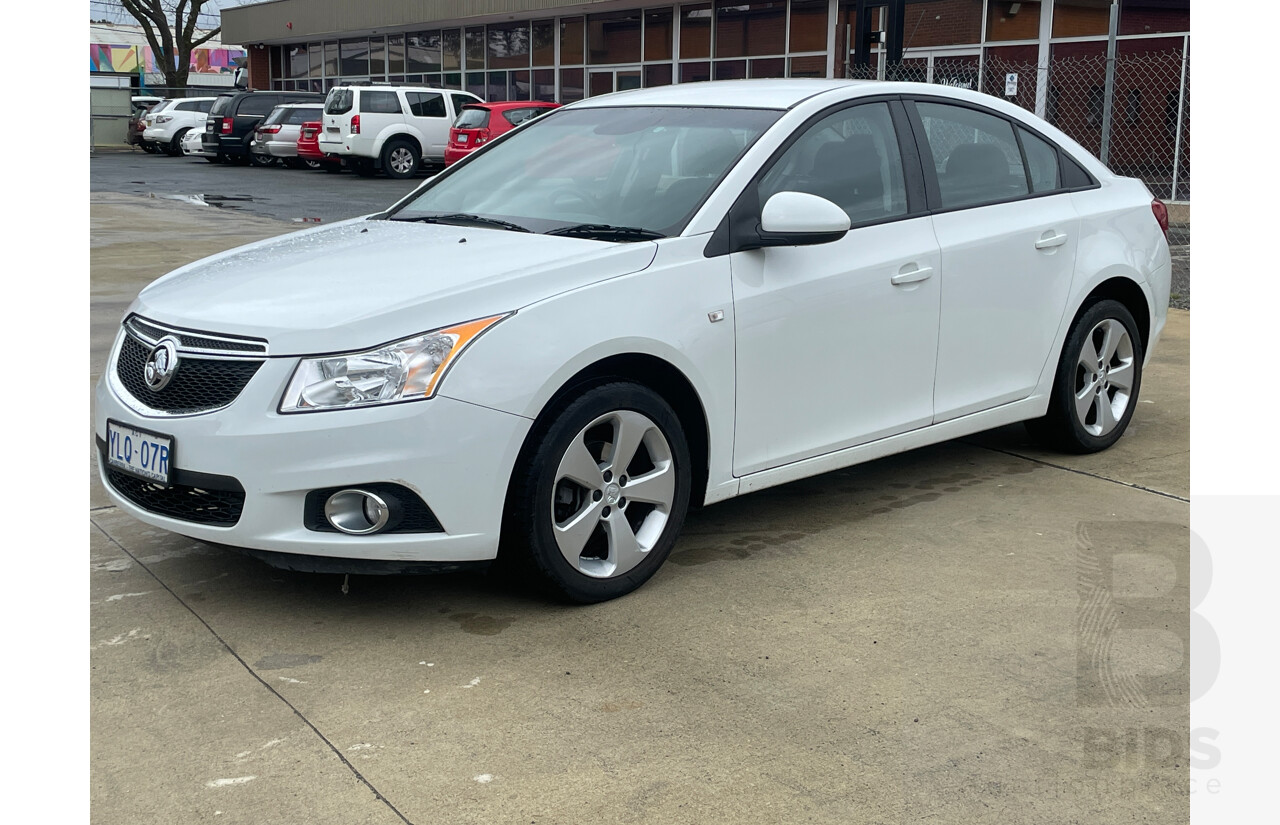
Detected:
[{"left": 93, "top": 332, "right": 532, "bottom": 563}]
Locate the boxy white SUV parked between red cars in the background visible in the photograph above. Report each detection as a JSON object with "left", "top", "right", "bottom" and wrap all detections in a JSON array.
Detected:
[{"left": 319, "top": 86, "right": 484, "bottom": 178}]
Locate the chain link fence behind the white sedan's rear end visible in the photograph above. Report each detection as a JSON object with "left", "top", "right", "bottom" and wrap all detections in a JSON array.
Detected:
[{"left": 846, "top": 43, "right": 1192, "bottom": 212}]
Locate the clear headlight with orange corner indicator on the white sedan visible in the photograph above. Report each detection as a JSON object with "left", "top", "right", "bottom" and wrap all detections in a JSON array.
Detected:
[{"left": 280, "top": 312, "right": 512, "bottom": 413}]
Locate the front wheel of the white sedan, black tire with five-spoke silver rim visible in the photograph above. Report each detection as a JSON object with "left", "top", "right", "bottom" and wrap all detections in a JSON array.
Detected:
[{"left": 500, "top": 381, "right": 691, "bottom": 604}]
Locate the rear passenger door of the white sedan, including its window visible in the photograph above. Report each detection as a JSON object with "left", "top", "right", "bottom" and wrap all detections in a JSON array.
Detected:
[{"left": 908, "top": 97, "right": 1080, "bottom": 422}]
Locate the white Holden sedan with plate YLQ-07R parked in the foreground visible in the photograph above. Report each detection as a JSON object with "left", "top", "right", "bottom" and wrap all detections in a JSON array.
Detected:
[{"left": 95, "top": 79, "right": 1170, "bottom": 602}]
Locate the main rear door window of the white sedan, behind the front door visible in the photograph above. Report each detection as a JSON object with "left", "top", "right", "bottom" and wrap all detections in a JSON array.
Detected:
[{"left": 916, "top": 102, "right": 1029, "bottom": 208}]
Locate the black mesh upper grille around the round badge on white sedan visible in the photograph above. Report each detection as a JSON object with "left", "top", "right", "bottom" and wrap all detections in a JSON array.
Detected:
[{"left": 115, "top": 333, "right": 262, "bottom": 416}]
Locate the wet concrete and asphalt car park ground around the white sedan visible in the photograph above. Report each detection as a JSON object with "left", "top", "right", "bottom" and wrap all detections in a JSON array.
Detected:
[{"left": 90, "top": 153, "right": 1189, "bottom": 822}]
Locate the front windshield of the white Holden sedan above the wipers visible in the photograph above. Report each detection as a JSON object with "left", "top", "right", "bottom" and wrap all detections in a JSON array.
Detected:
[{"left": 392, "top": 106, "right": 782, "bottom": 239}]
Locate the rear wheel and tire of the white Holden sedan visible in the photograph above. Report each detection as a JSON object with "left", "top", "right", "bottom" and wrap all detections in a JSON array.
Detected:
[{"left": 1027, "top": 299, "right": 1143, "bottom": 453}]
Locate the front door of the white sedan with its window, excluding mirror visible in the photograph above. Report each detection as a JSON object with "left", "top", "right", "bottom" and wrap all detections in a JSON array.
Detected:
[{"left": 730, "top": 102, "right": 940, "bottom": 476}]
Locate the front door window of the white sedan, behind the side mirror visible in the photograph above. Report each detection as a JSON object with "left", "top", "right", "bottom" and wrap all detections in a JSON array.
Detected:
[{"left": 759, "top": 104, "right": 906, "bottom": 224}]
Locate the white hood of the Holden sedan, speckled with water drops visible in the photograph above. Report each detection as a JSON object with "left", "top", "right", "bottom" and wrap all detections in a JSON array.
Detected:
[{"left": 131, "top": 219, "right": 657, "bottom": 356}]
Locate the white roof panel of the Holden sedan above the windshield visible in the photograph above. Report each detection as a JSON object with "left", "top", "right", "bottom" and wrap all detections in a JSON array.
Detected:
[{"left": 571, "top": 78, "right": 883, "bottom": 109}]
